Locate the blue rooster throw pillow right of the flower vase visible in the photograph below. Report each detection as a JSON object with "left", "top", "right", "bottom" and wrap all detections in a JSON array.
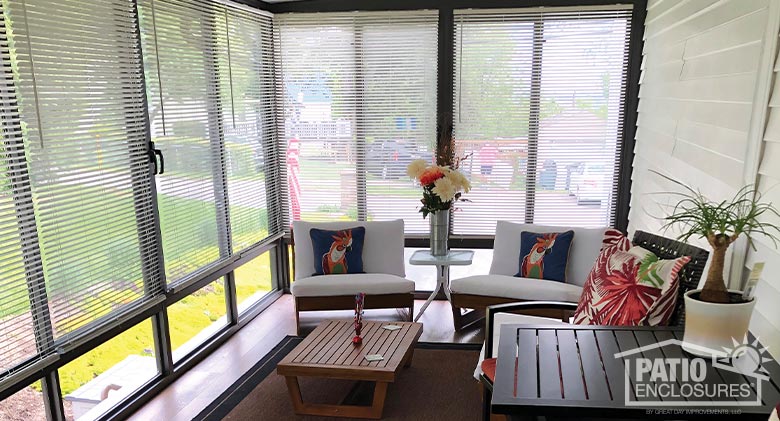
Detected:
[{"left": 515, "top": 231, "right": 574, "bottom": 282}]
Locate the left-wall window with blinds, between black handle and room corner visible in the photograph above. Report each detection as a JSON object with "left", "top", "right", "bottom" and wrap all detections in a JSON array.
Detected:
[{"left": 139, "top": 0, "right": 281, "bottom": 284}]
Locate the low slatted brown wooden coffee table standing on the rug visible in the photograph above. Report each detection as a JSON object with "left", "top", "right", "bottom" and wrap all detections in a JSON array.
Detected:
[{"left": 276, "top": 320, "right": 422, "bottom": 419}]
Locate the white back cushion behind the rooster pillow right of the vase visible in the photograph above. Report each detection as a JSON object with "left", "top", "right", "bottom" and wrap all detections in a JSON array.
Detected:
[{"left": 490, "top": 221, "right": 606, "bottom": 286}]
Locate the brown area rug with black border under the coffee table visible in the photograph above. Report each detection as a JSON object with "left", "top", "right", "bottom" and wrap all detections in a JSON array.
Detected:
[{"left": 195, "top": 337, "right": 481, "bottom": 420}]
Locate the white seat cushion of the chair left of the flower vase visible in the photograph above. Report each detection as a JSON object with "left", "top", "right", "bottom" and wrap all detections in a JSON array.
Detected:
[{"left": 290, "top": 273, "right": 414, "bottom": 300}]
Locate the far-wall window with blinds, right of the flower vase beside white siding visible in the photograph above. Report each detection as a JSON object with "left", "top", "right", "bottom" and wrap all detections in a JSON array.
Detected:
[{"left": 452, "top": 5, "right": 631, "bottom": 235}]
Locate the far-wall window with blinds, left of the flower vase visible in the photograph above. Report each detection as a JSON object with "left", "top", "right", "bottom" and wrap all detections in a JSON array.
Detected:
[{"left": 275, "top": 11, "right": 438, "bottom": 233}]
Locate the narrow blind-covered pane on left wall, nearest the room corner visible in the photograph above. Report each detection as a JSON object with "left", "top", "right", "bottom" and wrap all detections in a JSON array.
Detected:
[{"left": 222, "top": 8, "right": 282, "bottom": 251}]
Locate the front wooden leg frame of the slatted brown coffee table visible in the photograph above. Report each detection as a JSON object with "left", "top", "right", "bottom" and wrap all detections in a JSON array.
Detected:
[{"left": 284, "top": 376, "right": 387, "bottom": 419}]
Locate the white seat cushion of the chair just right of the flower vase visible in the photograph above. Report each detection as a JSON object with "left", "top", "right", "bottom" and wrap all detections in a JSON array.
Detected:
[{"left": 450, "top": 275, "right": 582, "bottom": 303}]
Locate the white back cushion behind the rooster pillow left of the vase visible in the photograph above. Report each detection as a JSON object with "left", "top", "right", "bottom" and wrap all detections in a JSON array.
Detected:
[{"left": 293, "top": 219, "right": 406, "bottom": 282}]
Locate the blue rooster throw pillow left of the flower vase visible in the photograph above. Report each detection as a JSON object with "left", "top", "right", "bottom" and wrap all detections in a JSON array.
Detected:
[{"left": 309, "top": 227, "right": 366, "bottom": 275}]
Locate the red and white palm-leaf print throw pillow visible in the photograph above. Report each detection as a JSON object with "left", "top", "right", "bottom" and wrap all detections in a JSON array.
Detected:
[{"left": 574, "top": 230, "right": 690, "bottom": 326}]
